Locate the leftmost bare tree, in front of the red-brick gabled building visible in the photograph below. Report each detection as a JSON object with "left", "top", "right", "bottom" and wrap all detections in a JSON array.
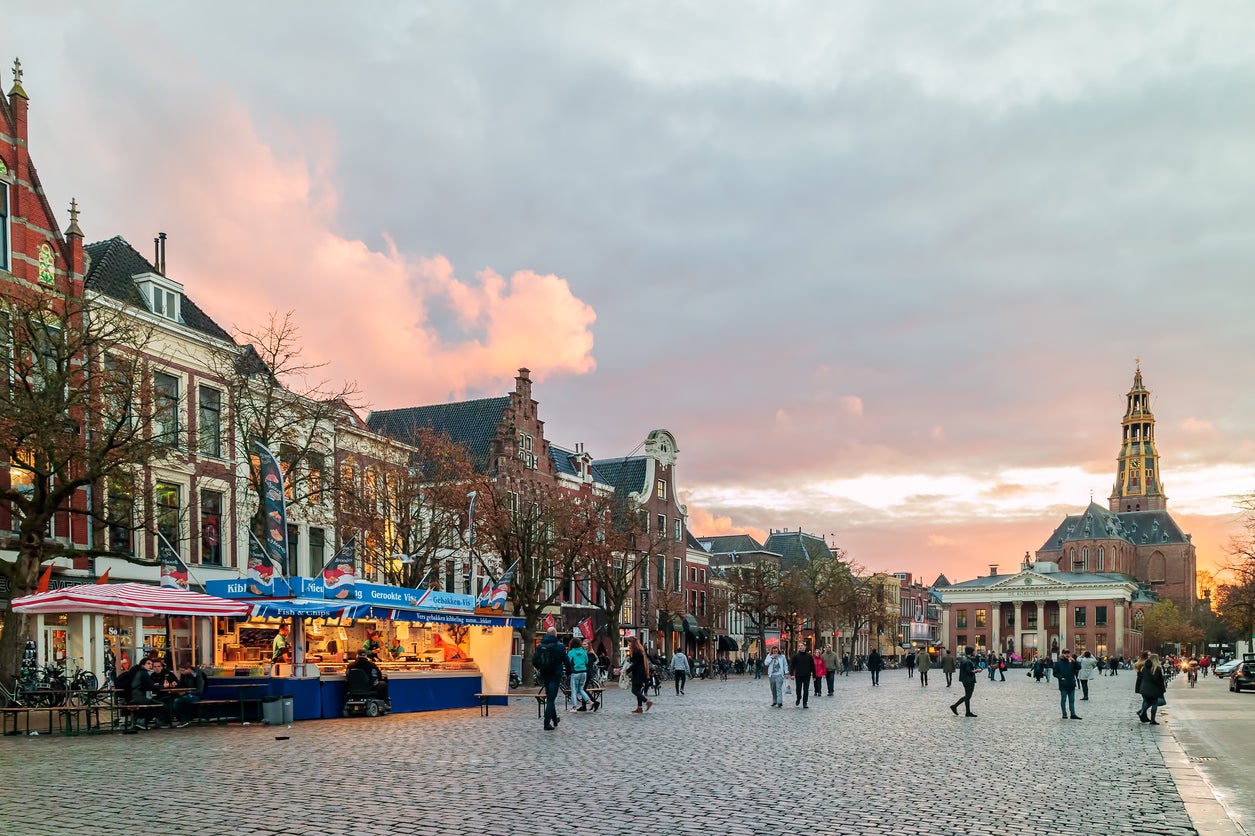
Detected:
[{"left": 0, "top": 289, "right": 169, "bottom": 684}]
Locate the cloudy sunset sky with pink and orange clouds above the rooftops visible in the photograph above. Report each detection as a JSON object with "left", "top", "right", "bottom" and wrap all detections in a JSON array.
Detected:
[{"left": 9, "top": 0, "right": 1255, "bottom": 580}]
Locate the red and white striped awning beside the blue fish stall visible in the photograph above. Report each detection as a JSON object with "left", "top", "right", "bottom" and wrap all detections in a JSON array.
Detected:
[{"left": 13, "top": 584, "right": 248, "bottom": 615}]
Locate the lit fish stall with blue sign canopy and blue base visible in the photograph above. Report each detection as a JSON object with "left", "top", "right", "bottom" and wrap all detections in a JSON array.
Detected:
[{"left": 208, "top": 577, "right": 521, "bottom": 719}]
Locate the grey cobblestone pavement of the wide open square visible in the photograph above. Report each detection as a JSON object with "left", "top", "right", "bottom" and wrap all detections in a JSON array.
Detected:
[{"left": 0, "top": 670, "right": 1214, "bottom": 836}]
